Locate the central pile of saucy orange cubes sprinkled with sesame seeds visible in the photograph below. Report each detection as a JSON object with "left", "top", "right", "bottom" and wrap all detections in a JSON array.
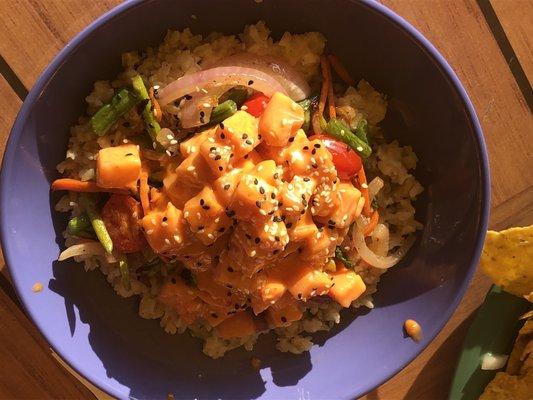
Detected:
[{"left": 107, "top": 93, "right": 365, "bottom": 338}]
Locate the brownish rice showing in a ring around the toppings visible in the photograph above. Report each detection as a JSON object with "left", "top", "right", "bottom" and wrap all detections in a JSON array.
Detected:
[{"left": 56, "top": 22, "right": 423, "bottom": 358}]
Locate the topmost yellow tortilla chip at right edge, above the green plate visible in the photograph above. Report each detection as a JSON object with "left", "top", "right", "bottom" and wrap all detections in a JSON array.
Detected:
[{"left": 480, "top": 225, "right": 533, "bottom": 296}]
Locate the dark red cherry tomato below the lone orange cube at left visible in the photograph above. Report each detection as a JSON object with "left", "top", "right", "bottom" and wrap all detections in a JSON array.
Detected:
[{"left": 101, "top": 194, "right": 145, "bottom": 253}]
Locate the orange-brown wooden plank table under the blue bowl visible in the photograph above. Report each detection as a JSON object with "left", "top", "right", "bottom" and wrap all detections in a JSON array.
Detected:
[{"left": 0, "top": 0, "right": 533, "bottom": 400}]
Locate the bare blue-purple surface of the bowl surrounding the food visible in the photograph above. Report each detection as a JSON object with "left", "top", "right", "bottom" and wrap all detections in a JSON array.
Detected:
[{"left": 0, "top": 0, "right": 490, "bottom": 399}]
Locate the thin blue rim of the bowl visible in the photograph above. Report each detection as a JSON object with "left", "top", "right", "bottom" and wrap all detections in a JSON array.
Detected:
[{"left": 0, "top": 0, "right": 490, "bottom": 398}]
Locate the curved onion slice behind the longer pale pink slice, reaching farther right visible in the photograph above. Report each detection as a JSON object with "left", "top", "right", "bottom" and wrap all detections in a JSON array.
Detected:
[{"left": 212, "top": 52, "right": 311, "bottom": 101}]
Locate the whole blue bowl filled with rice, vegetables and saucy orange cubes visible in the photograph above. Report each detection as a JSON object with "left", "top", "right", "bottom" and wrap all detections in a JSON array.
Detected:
[{"left": 0, "top": 0, "right": 490, "bottom": 398}]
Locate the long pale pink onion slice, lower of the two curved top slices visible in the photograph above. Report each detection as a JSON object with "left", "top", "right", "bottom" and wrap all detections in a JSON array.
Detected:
[{"left": 157, "top": 66, "right": 287, "bottom": 107}]
